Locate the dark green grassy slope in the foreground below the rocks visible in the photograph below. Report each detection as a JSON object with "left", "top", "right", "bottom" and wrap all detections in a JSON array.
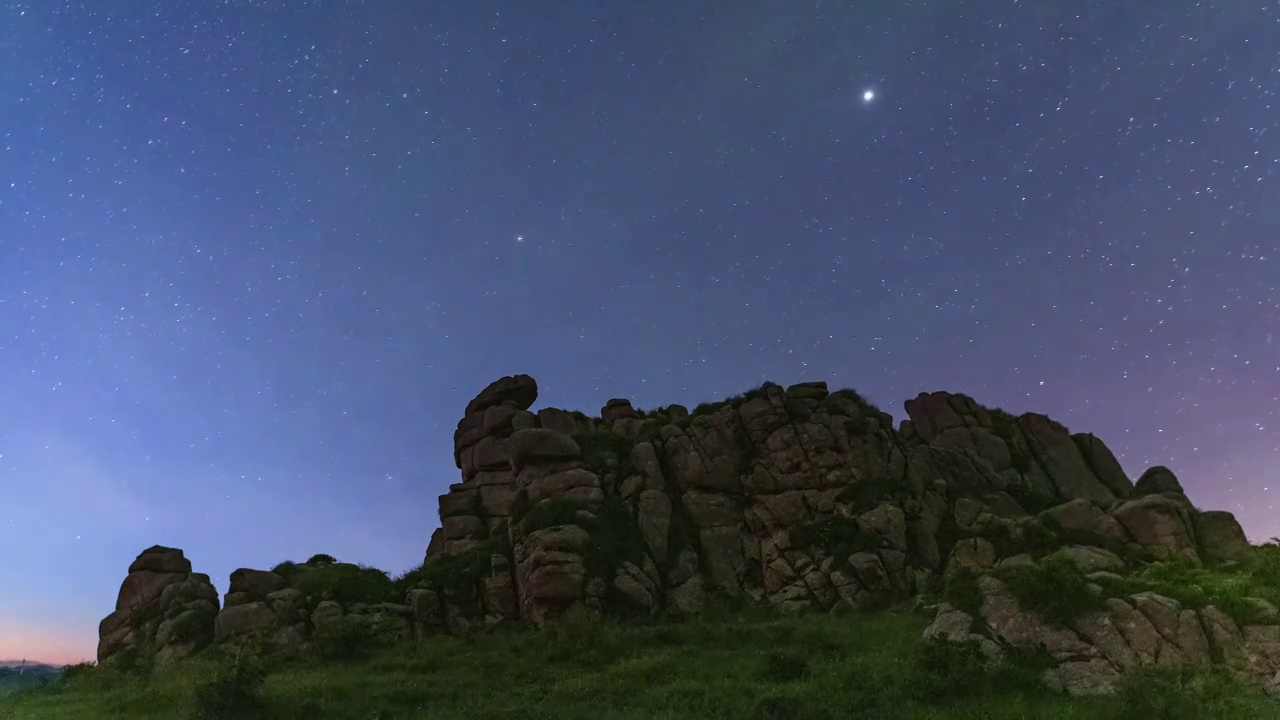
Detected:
[{"left": 10, "top": 611, "right": 1280, "bottom": 720}]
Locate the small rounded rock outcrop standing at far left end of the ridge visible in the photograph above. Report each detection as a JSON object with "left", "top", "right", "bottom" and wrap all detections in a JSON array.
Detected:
[{"left": 97, "top": 546, "right": 218, "bottom": 665}]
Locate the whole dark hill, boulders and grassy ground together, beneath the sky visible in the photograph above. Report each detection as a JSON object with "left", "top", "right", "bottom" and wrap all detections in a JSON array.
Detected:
[{"left": 2, "top": 375, "right": 1280, "bottom": 717}]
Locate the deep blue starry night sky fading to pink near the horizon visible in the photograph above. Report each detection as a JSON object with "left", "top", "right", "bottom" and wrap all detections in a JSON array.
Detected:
[{"left": 0, "top": 0, "right": 1280, "bottom": 661}]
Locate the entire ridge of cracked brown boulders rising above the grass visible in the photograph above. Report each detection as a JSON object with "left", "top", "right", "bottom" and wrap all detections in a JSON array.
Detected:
[{"left": 99, "top": 375, "right": 1280, "bottom": 694}]
